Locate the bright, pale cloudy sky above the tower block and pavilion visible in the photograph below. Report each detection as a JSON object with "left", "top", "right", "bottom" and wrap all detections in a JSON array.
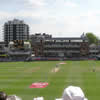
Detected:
[{"left": 0, "top": 0, "right": 100, "bottom": 37}]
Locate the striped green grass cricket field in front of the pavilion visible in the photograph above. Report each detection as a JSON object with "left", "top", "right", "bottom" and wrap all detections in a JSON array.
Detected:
[{"left": 0, "top": 61, "right": 100, "bottom": 100}]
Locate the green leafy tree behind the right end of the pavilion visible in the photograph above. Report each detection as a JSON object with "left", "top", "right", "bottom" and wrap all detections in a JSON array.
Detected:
[{"left": 86, "top": 33, "right": 99, "bottom": 44}]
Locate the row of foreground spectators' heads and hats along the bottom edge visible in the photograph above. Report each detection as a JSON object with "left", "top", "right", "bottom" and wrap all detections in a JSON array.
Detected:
[{"left": 0, "top": 86, "right": 88, "bottom": 100}]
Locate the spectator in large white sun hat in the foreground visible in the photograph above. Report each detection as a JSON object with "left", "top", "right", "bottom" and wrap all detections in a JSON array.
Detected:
[{"left": 62, "top": 86, "right": 88, "bottom": 100}]
